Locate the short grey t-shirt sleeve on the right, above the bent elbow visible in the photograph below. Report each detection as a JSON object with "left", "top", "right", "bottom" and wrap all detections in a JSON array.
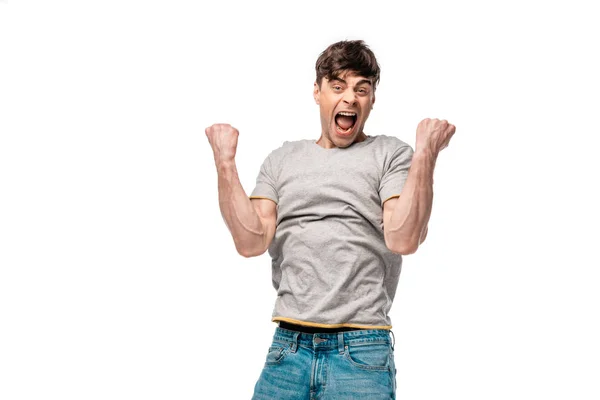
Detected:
[{"left": 379, "top": 145, "right": 414, "bottom": 206}]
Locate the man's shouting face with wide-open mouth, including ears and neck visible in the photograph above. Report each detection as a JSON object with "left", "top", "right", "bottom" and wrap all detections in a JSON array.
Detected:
[{"left": 313, "top": 72, "right": 375, "bottom": 148}]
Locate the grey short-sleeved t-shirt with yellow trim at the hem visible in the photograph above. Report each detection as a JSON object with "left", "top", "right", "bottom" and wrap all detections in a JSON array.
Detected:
[{"left": 249, "top": 135, "right": 413, "bottom": 329}]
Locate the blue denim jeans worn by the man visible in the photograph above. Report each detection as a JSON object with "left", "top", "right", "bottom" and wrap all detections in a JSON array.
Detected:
[{"left": 252, "top": 327, "right": 396, "bottom": 400}]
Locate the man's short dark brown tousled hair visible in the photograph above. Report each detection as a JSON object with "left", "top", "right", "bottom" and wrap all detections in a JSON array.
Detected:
[{"left": 315, "top": 40, "right": 380, "bottom": 88}]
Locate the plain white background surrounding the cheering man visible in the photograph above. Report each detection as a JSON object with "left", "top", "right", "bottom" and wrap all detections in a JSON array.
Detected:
[{"left": 0, "top": 0, "right": 600, "bottom": 400}]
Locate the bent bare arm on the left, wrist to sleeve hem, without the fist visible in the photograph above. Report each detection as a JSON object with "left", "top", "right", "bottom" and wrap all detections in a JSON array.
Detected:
[{"left": 217, "top": 160, "right": 276, "bottom": 257}]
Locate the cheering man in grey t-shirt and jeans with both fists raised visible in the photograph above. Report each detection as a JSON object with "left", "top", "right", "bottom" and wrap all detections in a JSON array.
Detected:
[{"left": 206, "top": 41, "right": 455, "bottom": 400}]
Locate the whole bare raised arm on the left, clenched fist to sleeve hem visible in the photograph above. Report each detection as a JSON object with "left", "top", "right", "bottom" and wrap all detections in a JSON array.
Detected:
[{"left": 205, "top": 124, "right": 277, "bottom": 257}]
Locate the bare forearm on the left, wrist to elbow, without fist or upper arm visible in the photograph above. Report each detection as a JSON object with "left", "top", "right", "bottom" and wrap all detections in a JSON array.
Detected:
[{"left": 217, "top": 160, "right": 265, "bottom": 256}]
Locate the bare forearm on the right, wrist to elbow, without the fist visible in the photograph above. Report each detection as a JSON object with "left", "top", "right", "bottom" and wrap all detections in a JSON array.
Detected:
[{"left": 386, "top": 150, "right": 436, "bottom": 254}]
